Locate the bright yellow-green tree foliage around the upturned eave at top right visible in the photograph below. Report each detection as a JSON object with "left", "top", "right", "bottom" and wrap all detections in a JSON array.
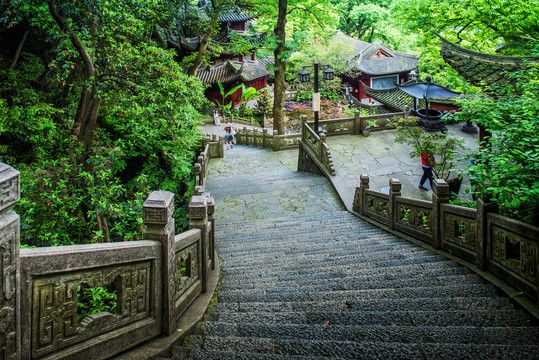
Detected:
[{"left": 394, "top": 0, "right": 539, "bottom": 88}]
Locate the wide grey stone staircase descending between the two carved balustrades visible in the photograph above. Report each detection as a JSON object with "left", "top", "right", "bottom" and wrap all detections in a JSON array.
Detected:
[{"left": 172, "top": 147, "right": 539, "bottom": 360}]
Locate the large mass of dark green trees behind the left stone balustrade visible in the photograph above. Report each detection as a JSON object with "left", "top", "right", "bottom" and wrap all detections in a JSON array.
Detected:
[{"left": 0, "top": 0, "right": 205, "bottom": 246}]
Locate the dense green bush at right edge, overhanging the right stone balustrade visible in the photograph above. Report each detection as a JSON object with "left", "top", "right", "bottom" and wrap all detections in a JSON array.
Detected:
[{"left": 454, "top": 65, "right": 539, "bottom": 223}]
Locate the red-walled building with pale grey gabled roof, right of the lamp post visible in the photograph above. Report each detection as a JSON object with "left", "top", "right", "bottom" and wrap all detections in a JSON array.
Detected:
[{"left": 335, "top": 32, "right": 419, "bottom": 104}]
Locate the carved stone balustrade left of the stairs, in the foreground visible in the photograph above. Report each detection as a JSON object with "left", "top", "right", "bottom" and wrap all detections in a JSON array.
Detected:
[{"left": 0, "top": 163, "right": 218, "bottom": 359}]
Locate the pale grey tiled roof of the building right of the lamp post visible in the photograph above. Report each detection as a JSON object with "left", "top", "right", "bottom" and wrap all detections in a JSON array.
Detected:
[{"left": 335, "top": 31, "right": 419, "bottom": 75}]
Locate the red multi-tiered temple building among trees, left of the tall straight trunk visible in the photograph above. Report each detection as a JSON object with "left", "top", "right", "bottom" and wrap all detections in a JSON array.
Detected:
[{"left": 165, "top": 0, "right": 273, "bottom": 107}]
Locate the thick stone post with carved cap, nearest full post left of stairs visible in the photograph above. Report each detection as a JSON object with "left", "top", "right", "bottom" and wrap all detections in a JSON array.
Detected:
[{"left": 143, "top": 191, "right": 176, "bottom": 336}]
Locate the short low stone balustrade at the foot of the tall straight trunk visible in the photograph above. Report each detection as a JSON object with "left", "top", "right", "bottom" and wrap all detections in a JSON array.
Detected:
[{"left": 236, "top": 127, "right": 301, "bottom": 151}]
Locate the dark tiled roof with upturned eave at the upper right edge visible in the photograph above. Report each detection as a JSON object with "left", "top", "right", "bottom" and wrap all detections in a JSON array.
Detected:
[{"left": 436, "top": 34, "right": 539, "bottom": 86}]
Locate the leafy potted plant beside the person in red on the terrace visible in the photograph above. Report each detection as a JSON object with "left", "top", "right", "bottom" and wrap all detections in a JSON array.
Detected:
[{"left": 395, "top": 118, "right": 464, "bottom": 198}]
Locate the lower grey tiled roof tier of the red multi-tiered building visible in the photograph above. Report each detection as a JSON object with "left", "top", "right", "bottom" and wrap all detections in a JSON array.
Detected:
[{"left": 195, "top": 59, "right": 273, "bottom": 84}]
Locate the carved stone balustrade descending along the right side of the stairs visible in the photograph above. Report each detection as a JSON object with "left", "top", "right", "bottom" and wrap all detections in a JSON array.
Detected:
[{"left": 353, "top": 175, "right": 539, "bottom": 304}]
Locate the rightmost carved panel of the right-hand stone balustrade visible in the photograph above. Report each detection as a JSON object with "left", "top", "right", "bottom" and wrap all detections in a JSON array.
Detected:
[{"left": 492, "top": 225, "right": 538, "bottom": 283}]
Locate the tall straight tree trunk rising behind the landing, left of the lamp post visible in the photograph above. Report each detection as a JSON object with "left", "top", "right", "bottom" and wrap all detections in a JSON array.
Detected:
[{"left": 273, "top": 0, "right": 288, "bottom": 135}]
